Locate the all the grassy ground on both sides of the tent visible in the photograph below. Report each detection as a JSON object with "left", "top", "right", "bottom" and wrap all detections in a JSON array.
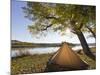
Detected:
[{"left": 11, "top": 48, "right": 96, "bottom": 75}]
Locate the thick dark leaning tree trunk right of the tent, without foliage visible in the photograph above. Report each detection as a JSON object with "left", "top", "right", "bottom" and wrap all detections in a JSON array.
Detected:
[{"left": 76, "top": 31, "right": 95, "bottom": 60}]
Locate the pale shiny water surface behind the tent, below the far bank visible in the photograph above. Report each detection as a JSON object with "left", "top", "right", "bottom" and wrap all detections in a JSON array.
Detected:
[{"left": 11, "top": 46, "right": 94, "bottom": 57}]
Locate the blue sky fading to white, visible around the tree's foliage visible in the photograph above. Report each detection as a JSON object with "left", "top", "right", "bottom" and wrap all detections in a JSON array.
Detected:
[{"left": 11, "top": 0, "right": 95, "bottom": 43}]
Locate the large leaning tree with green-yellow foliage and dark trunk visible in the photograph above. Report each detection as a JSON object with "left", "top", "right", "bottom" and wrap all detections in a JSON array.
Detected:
[{"left": 23, "top": 2, "right": 95, "bottom": 60}]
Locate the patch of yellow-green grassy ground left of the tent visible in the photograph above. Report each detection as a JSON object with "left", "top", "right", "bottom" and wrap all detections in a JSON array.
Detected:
[{"left": 11, "top": 54, "right": 52, "bottom": 75}]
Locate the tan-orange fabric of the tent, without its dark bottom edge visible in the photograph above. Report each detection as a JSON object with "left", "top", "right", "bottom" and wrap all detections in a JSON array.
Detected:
[{"left": 46, "top": 42, "right": 88, "bottom": 69}]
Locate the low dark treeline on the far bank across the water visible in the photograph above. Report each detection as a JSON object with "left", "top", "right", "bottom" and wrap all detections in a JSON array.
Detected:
[{"left": 11, "top": 41, "right": 75, "bottom": 48}]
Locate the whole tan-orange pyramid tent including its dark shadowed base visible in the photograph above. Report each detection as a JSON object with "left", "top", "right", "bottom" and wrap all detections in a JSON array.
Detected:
[{"left": 46, "top": 42, "right": 88, "bottom": 72}]
